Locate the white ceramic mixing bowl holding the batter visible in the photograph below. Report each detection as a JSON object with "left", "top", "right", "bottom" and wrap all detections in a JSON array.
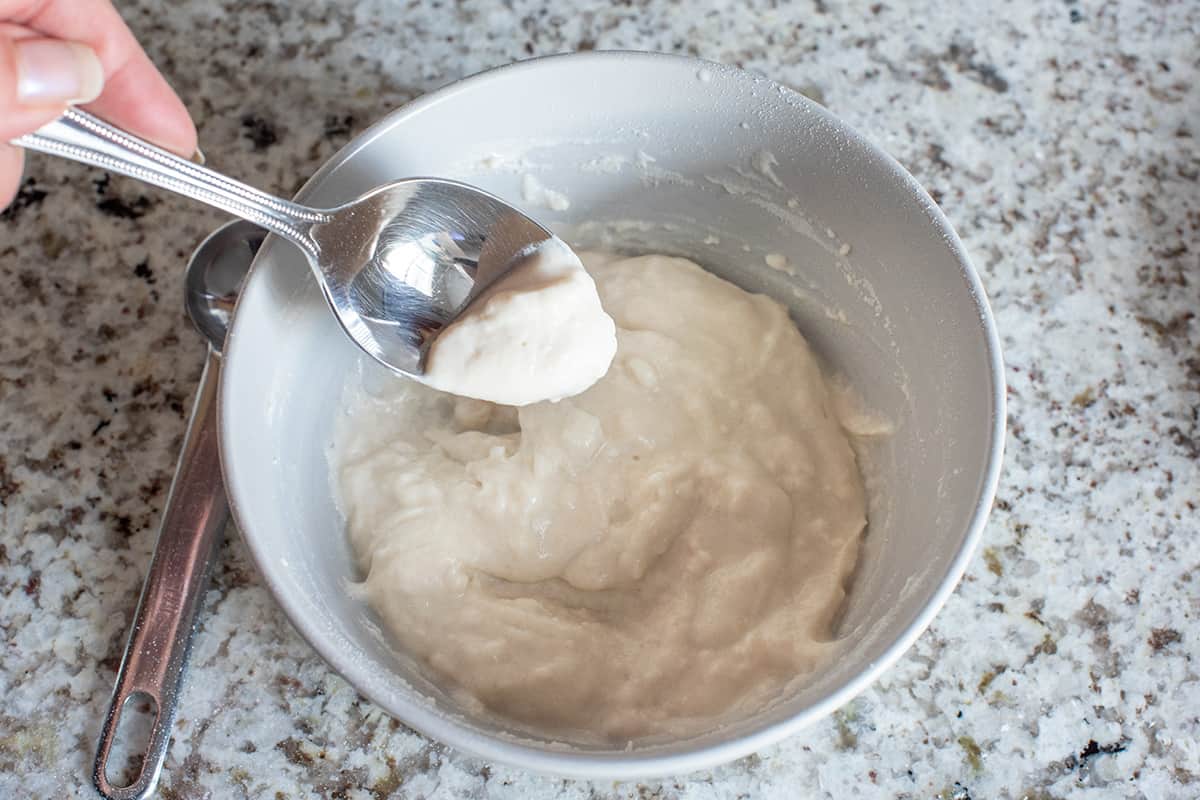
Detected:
[{"left": 220, "top": 53, "right": 1004, "bottom": 778}]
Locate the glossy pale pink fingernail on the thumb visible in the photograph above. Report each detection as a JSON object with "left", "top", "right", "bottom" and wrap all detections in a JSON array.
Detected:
[{"left": 16, "top": 38, "right": 104, "bottom": 103}]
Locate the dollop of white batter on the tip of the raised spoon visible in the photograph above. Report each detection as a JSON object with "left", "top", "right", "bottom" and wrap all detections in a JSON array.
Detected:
[{"left": 422, "top": 239, "right": 617, "bottom": 405}]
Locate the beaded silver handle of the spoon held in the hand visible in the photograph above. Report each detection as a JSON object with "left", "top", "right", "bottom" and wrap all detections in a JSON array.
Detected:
[{"left": 13, "top": 108, "right": 329, "bottom": 254}]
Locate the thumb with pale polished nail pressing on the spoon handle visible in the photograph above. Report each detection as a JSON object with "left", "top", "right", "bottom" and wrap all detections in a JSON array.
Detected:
[{"left": 0, "top": 29, "right": 104, "bottom": 142}]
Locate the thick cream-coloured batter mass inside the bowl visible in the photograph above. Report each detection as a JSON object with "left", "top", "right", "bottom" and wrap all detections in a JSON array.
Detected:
[{"left": 334, "top": 255, "right": 865, "bottom": 741}]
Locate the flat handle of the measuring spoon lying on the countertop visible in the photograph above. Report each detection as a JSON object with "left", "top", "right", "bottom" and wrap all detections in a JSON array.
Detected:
[{"left": 92, "top": 349, "right": 229, "bottom": 800}]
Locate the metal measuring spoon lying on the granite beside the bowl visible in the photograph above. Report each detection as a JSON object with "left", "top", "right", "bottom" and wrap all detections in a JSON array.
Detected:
[{"left": 92, "top": 221, "right": 266, "bottom": 800}]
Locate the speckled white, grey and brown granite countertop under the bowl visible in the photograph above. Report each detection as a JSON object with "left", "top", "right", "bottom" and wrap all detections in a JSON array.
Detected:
[{"left": 0, "top": 0, "right": 1200, "bottom": 800}]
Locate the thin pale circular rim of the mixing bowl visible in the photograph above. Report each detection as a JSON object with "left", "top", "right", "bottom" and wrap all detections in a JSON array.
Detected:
[{"left": 218, "top": 50, "right": 1007, "bottom": 780}]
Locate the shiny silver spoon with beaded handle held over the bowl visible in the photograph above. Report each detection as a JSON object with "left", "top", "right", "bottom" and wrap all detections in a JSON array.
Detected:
[{"left": 13, "top": 108, "right": 553, "bottom": 378}]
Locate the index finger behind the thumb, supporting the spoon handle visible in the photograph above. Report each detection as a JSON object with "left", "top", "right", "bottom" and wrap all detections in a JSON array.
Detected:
[{"left": 0, "top": 0, "right": 196, "bottom": 156}]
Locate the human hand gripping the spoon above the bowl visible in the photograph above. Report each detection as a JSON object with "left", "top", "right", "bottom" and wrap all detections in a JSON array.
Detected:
[{"left": 0, "top": 0, "right": 196, "bottom": 209}]
